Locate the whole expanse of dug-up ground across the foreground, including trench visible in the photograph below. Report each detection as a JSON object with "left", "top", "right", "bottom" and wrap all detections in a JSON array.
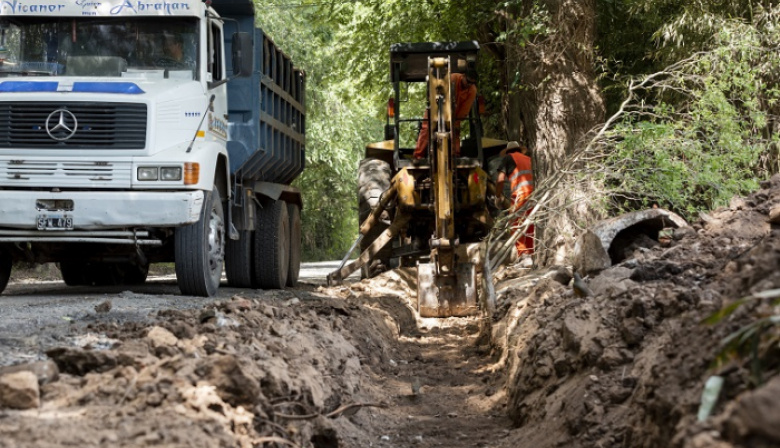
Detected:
[{"left": 0, "top": 177, "right": 780, "bottom": 448}]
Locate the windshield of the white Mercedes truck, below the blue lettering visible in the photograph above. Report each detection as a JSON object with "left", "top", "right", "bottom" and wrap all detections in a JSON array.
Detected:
[{"left": 0, "top": 17, "right": 198, "bottom": 80}]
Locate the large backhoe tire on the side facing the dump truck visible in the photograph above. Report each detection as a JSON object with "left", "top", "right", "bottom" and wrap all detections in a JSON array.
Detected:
[{"left": 358, "top": 158, "right": 393, "bottom": 278}]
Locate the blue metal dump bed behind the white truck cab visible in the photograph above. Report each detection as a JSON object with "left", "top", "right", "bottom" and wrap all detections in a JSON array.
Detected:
[{"left": 218, "top": 0, "right": 306, "bottom": 184}]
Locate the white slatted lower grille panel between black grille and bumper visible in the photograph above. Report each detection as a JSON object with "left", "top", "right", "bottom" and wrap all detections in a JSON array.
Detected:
[{"left": 0, "top": 160, "right": 133, "bottom": 188}]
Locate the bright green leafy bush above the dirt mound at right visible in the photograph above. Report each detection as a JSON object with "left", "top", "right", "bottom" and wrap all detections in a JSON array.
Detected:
[{"left": 608, "top": 9, "right": 780, "bottom": 218}]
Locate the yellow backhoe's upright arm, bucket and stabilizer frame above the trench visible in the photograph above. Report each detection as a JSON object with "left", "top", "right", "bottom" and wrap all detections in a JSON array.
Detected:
[{"left": 328, "top": 43, "right": 491, "bottom": 317}]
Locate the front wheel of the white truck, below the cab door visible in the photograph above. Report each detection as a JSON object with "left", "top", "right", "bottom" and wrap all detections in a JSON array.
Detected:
[{"left": 174, "top": 186, "right": 225, "bottom": 297}]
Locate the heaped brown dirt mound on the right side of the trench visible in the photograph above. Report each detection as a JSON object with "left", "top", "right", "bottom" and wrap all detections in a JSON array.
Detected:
[{"left": 493, "top": 176, "right": 780, "bottom": 448}]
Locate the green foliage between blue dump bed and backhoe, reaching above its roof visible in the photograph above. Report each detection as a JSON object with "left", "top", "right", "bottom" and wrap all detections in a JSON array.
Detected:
[{"left": 255, "top": 0, "right": 512, "bottom": 260}]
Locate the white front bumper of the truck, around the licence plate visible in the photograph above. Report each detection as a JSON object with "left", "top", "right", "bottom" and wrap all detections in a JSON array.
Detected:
[{"left": 0, "top": 190, "right": 203, "bottom": 233}]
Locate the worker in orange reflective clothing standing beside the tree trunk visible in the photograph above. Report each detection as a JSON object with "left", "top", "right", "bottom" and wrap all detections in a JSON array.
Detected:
[{"left": 496, "top": 142, "right": 534, "bottom": 256}]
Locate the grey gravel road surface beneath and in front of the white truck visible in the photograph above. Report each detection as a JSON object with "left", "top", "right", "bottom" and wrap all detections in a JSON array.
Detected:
[{"left": 0, "top": 261, "right": 354, "bottom": 365}]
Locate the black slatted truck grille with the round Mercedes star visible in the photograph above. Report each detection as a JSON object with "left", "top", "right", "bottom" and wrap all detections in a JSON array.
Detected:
[{"left": 0, "top": 102, "right": 147, "bottom": 149}]
